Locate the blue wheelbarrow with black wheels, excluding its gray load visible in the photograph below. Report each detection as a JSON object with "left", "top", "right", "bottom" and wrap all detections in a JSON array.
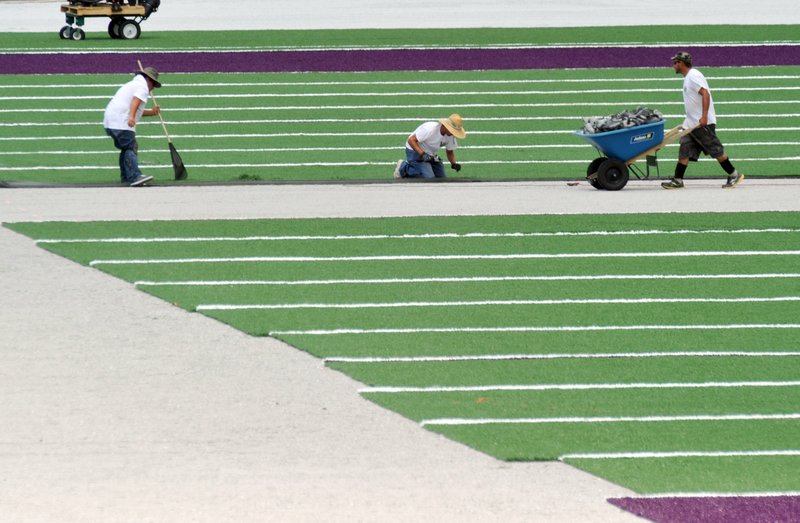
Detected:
[{"left": 575, "top": 120, "right": 692, "bottom": 191}]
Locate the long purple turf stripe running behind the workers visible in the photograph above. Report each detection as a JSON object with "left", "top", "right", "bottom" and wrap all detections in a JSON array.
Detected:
[{"left": 0, "top": 45, "right": 800, "bottom": 74}]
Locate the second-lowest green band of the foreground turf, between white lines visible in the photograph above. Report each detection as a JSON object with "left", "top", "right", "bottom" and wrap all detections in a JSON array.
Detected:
[{"left": 426, "top": 420, "right": 800, "bottom": 462}]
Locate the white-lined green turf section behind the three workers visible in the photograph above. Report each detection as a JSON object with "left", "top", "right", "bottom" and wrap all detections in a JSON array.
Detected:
[{"left": 0, "top": 67, "right": 800, "bottom": 184}]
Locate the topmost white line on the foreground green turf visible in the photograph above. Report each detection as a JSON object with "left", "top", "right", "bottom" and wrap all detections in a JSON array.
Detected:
[{"left": 36, "top": 227, "right": 800, "bottom": 244}]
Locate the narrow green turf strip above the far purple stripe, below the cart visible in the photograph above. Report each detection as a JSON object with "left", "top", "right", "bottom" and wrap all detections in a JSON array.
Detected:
[{"left": 0, "top": 26, "right": 798, "bottom": 52}]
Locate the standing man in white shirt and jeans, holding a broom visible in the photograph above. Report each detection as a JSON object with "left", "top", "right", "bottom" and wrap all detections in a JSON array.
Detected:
[{"left": 103, "top": 67, "right": 161, "bottom": 187}]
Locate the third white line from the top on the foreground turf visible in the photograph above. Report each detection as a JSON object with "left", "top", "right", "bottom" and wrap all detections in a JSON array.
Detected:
[{"left": 134, "top": 273, "right": 800, "bottom": 287}]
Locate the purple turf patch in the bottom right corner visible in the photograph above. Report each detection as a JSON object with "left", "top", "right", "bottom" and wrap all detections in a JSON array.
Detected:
[{"left": 608, "top": 496, "right": 800, "bottom": 523}]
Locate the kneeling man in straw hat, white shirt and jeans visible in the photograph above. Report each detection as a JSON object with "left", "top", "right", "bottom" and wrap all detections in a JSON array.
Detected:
[{"left": 394, "top": 114, "right": 467, "bottom": 178}]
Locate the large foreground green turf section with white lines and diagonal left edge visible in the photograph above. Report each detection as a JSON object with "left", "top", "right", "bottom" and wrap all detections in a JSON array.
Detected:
[{"left": 5, "top": 210, "right": 800, "bottom": 493}]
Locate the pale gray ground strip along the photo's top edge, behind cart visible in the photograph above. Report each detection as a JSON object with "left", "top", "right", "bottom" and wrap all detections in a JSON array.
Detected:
[{"left": 0, "top": 0, "right": 800, "bottom": 31}]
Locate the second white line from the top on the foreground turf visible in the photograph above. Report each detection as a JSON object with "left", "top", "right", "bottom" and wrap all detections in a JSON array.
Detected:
[{"left": 89, "top": 250, "right": 800, "bottom": 266}]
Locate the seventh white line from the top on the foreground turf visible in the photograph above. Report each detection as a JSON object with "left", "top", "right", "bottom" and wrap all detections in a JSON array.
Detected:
[{"left": 358, "top": 381, "right": 800, "bottom": 394}]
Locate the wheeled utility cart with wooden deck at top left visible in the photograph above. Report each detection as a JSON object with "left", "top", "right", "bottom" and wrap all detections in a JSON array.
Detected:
[{"left": 58, "top": 0, "right": 161, "bottom": 40}]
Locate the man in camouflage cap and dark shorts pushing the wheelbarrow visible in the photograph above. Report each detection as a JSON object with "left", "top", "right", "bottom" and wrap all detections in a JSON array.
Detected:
[{"left": 661, "top": 52, "right": 744, "bottom": 189}]
